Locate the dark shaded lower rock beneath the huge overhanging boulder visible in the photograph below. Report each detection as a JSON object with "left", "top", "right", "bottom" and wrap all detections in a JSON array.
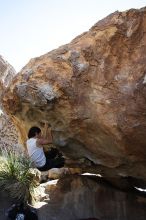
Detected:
[{"left": 36, "top": 176, "right": 146, "bottom": 220}]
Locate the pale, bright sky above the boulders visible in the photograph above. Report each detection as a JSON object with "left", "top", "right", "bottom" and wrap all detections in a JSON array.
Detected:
[{"left": 0, "top": 0, "right": 146, "bottom": 71}]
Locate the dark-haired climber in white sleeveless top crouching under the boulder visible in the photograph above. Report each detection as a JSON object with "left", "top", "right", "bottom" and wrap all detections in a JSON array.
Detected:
[{"left": 26, "top": 124, "right": 64, "bottom": 171}]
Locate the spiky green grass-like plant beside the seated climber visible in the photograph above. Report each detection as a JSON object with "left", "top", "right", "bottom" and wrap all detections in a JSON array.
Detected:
[{"left": 0, "top": 150, "right": 38, "bottom": 205}]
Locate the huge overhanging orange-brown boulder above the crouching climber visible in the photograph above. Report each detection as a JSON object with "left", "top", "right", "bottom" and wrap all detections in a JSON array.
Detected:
[{"left": 3, "top": 8, "right": 146, "bottom": 184}]
